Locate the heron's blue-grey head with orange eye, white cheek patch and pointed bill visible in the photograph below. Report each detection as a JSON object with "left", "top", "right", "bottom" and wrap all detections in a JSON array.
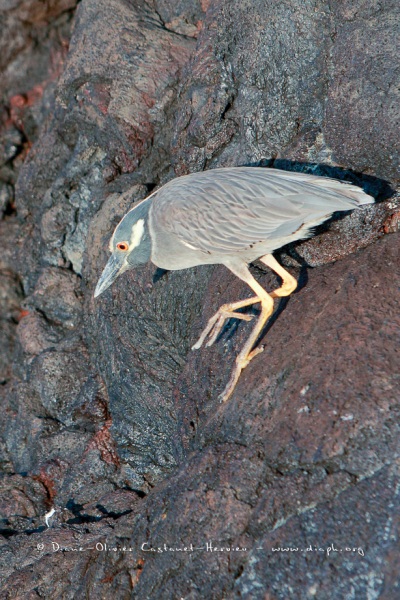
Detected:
[{"left": 94, "top": 199, "right": 151, "bottom": 298}]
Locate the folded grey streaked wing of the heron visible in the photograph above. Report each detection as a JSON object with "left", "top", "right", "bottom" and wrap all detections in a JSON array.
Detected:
[{"left": 151, "top": 167, "right": 371, "bottom": 254}]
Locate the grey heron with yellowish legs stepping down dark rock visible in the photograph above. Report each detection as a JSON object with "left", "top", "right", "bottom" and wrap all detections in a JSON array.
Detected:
[{"left": 94, "top": 167, "right": 374, "bottom": 402}]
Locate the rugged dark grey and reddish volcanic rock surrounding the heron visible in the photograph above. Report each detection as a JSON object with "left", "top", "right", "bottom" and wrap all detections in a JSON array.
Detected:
[{"left": 0, "top": 0, "right": 400, "bottom": 600}]
